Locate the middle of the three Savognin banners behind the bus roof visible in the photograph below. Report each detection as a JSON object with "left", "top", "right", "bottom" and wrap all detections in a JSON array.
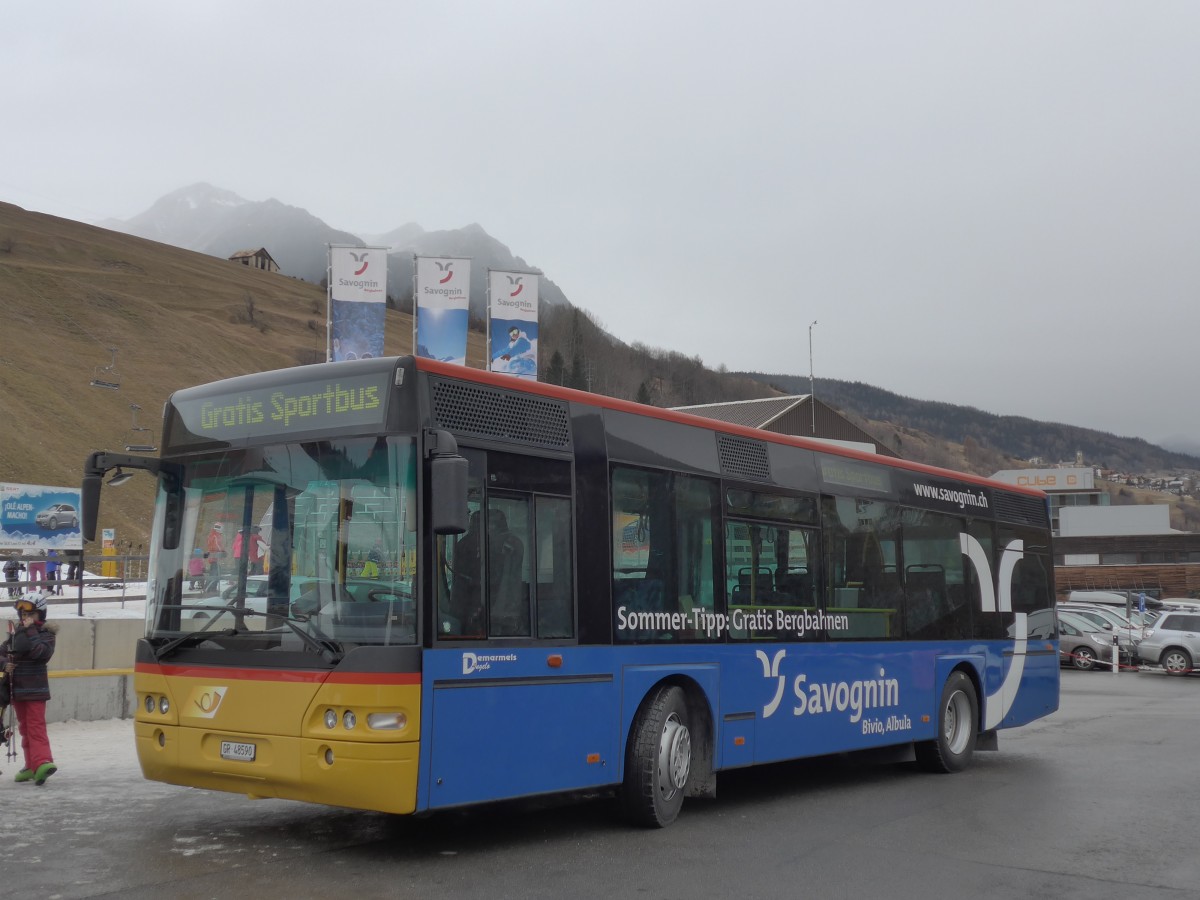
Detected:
[{"left": 413, "top": 257, "right": 470, "bottom": 366}]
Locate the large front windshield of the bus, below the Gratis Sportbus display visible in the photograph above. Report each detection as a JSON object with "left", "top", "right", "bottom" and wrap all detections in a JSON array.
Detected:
[{"left": 146, "top": 436, "right": 416, "bottom": 656}]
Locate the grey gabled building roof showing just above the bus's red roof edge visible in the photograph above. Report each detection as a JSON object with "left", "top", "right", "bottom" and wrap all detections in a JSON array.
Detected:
[{"left": 676, "top": 394, "right": 899, "bottom": 457}]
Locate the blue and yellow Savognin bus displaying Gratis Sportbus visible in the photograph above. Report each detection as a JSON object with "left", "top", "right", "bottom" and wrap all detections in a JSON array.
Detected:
[{"left": 83, "top": 358, "right": 1058, "bottom": 826}]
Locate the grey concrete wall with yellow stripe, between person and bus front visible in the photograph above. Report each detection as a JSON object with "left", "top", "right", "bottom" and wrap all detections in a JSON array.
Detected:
[{"left": 46, "top": 619, "right": 145, "bottom": 722}]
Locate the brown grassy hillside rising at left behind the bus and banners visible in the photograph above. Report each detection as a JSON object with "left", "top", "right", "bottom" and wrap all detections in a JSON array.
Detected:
[{"left": 0, "top": 203, "right": 484, "bottom": 545}]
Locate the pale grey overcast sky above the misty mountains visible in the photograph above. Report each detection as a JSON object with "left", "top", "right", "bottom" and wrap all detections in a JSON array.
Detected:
[{"left": 9, "top": 0, "right": 1200, "bottom": 451}]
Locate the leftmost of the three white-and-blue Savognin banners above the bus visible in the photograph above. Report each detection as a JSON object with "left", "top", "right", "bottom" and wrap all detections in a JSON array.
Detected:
[{"left": 326, "top": 246, "right": 388, "bottom": 362}]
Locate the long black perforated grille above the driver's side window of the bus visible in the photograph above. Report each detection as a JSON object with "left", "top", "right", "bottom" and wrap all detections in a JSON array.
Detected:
[{"left": 433, "top": 380, "right": 571, "bottom": 450}]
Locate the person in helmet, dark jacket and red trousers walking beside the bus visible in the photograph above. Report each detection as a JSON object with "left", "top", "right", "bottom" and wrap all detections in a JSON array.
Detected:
[{"left": 0, "top": 590, "right": 59, "bottom": 787}]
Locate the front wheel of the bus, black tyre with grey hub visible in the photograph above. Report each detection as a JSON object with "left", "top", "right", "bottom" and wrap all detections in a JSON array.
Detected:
[{"left": 622, "top": 684, "right": 691, "bottom": 828}]
